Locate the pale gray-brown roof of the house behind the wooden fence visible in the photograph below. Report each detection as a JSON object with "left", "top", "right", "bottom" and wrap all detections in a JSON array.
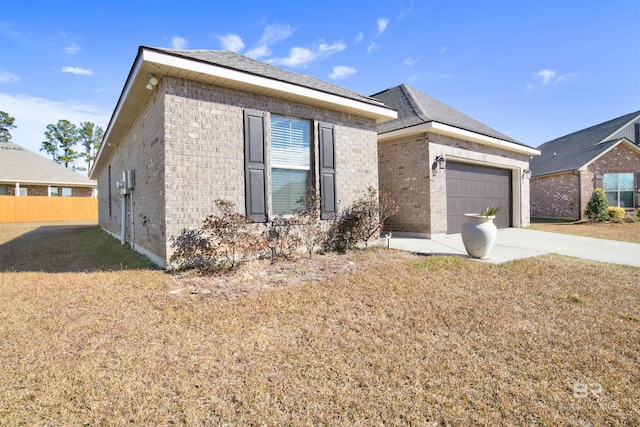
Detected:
[{"left": 0, "top": 142, "right": 96, "bottom": 187}]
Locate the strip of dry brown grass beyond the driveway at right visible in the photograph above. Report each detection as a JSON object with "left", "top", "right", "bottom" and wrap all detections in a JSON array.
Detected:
[{"left": 529, "top": 221, "right": 640, "bottom": 243}]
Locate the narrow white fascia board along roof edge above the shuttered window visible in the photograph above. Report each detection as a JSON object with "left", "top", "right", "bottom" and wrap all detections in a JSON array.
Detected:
[{"left": 142, "top": 50, "right": 398, "bottom": 121}]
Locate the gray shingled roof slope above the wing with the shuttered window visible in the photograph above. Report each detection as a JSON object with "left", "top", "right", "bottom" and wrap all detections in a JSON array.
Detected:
[{"left": 143, "top": 46, "right": 380, "bottom": 106}]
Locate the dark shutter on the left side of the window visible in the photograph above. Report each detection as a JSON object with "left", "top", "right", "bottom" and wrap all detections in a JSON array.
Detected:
[{"left": 244, "top": 110, "right": 267, "bottom": 222}]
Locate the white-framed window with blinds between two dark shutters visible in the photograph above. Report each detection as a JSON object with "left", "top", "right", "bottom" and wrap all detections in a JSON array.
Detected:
[{"left": 271, "top": 114, "right": 312, "bottom": 215}]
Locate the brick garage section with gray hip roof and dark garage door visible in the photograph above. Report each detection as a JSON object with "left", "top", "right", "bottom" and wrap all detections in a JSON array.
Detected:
[{"left": 372, "top": 84, "right": 540, "bottom": 237}]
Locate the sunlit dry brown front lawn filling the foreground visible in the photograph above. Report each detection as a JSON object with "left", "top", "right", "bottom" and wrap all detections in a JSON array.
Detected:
[{"left": 0, "top": 222, "right": 640, "bottom": 426}]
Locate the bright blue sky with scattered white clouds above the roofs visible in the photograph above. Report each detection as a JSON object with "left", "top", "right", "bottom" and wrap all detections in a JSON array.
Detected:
[{"left": 0, "top": 0, "right": 640, "bottom": 172}]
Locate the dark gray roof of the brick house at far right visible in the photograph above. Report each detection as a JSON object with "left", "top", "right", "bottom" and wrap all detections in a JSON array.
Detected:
[{"left": 529, "top": 111, "right": 640, "bottom": 176}]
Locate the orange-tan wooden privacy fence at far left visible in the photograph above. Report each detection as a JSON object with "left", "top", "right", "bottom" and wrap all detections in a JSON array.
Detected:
[{"left": 0, "top": 196, "right": 98, "bottom": 222}]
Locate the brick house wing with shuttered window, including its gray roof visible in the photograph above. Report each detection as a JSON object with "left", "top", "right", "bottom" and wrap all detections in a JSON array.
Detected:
[{"left": 90, "top": 47, "right": 397, "bottom": 266}]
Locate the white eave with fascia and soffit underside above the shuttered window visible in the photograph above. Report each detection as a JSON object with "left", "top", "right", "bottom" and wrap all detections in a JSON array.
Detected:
[{"left": 142, "top": 50, "right": 398, "bottom": 122}]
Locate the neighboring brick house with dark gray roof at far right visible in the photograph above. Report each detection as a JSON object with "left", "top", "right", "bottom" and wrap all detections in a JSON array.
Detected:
[{"left": 531, "top": 111, "right": 640, "bottom": 219}]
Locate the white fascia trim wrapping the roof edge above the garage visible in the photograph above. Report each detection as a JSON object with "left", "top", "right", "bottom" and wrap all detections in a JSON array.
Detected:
[{"left": 378, "top": 122, "right": 540, "bottom": 156}]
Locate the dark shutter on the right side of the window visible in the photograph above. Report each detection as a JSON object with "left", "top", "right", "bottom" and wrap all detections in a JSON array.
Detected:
[{"left": 318, "top": 123, "right": 337, "bottom": 219}]
